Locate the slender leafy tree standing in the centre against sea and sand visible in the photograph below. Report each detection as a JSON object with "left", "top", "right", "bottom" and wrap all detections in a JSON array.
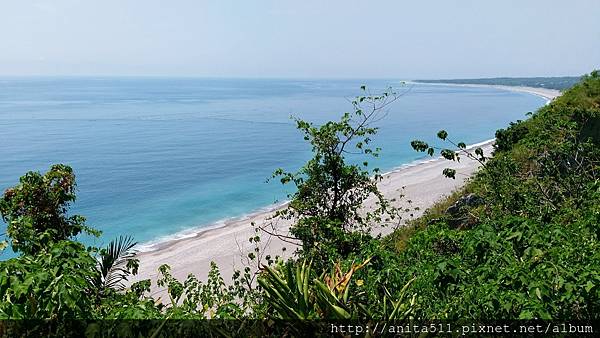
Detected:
[{"left": 273, "top": 86, "right": 398, "bottom": 265}]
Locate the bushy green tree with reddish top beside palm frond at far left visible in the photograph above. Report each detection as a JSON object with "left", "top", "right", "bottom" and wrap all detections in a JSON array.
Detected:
[{"left": 0, "top": 164, "right": 143, "bottom": 318}]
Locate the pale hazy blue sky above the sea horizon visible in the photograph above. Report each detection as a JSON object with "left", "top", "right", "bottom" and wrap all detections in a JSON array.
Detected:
[{"left": 0, "top": 0, "right": 600, "bottom": 79}]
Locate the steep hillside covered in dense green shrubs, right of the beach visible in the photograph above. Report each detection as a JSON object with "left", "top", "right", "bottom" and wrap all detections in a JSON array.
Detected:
[{"left": 386, "top": 72, "right": 600, "bottom": 319}]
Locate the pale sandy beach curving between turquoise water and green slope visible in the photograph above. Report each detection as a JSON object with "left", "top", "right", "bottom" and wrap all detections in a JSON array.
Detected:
[{"left": 135, "top": 85, "right": 560, "bottom": 294}]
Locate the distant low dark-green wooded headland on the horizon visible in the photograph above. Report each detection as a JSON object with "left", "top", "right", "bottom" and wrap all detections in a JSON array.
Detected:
[{"left": 415, "top": 76, "right": 581, "bottom": 90}]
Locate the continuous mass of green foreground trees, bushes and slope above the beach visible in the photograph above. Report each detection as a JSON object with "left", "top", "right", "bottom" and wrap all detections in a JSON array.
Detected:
[{"left": 0, "top": 72, "right": 600, "bottom": 337}]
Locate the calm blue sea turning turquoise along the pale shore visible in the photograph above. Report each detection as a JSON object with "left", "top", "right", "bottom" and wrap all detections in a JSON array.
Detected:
[{"left": 0, "top": 77, "right": 545, "bottom": 257}]
